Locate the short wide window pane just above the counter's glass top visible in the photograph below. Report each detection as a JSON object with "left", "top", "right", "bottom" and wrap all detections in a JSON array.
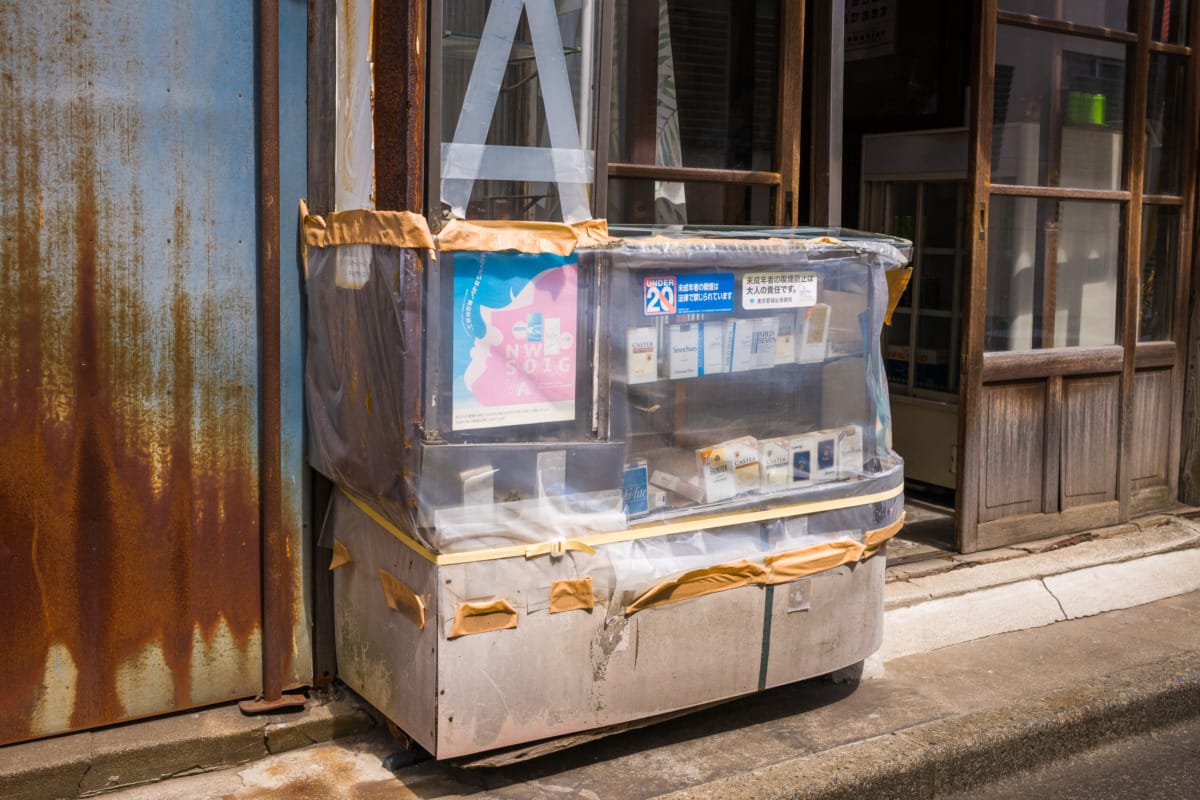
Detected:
[{"left": 608, "top": 178, "right": 774, "bottom": 225}]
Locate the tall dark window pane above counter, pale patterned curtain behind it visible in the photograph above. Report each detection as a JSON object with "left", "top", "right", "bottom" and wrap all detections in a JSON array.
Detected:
[{"left": 608, "top": 0, "right": 780, "bottom": 223}]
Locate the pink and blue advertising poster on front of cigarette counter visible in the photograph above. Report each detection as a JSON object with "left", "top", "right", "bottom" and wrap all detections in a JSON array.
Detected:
[{"left": 450, "top": 252, "right": 578, "bottom": 431}]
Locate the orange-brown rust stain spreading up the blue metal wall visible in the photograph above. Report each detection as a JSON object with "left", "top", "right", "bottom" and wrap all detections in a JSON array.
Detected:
[{"left": 0, "top": 4, "right": 274, "bottom": 745}]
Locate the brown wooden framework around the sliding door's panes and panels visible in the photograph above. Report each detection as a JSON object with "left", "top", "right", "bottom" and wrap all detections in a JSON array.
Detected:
[{"left": 955, "top": 0, "right": 1200, "bottom": 553}]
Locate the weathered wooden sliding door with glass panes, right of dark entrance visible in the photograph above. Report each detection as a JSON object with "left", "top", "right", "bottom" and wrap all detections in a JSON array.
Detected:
[{"left": 958, "top": 0, "right": 1198, "bottom": 552}]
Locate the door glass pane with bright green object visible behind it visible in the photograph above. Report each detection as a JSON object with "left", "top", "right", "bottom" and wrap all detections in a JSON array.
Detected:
[{"left": 991, "top": 25, "right": 1126, "bottom": 190}]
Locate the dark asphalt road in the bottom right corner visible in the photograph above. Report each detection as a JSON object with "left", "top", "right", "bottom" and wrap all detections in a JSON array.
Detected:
[{"left": 960, "top": 718, "right": 1200, "bottom": 800}]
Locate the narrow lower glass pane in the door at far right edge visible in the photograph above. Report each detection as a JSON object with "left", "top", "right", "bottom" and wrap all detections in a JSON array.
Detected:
[{"left": 1138, "top": 205, "right": 1180, "bottom": 342}]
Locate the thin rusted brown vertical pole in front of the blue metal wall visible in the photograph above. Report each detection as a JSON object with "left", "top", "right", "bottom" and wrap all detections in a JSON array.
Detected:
[{"left": 240, "top": 0, "right": 305, "bottom": 714}]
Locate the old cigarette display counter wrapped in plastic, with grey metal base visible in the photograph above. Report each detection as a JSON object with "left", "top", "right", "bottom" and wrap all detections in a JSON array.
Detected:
[{"left": 305, "top": 212, "right": 907, "bottom": 758}]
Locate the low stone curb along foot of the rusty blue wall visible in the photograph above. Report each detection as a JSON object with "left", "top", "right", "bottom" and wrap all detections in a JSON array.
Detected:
[{"left": 0, "top": 698, "right": 376, "bottom": 800}]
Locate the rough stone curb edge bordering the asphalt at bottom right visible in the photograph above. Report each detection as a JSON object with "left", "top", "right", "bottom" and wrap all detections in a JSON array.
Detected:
[{"left": 658, "top": 652, "right": 1200, "bottom": 800}]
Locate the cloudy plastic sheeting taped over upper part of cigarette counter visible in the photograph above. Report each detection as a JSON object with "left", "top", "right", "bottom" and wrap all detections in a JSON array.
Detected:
[{"left": 307, "top": 212, "right": 908, "bottom": 614}]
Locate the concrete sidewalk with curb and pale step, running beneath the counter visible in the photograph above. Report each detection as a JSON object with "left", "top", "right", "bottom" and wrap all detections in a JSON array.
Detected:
[{"left": 0, "top": 515, "right": 1200, "bottom": 800}]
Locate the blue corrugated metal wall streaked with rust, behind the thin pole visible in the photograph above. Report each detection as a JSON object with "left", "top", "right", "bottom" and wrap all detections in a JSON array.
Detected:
[{"left": 0, "top": 0, "right": 311, "bottom": 744}]
